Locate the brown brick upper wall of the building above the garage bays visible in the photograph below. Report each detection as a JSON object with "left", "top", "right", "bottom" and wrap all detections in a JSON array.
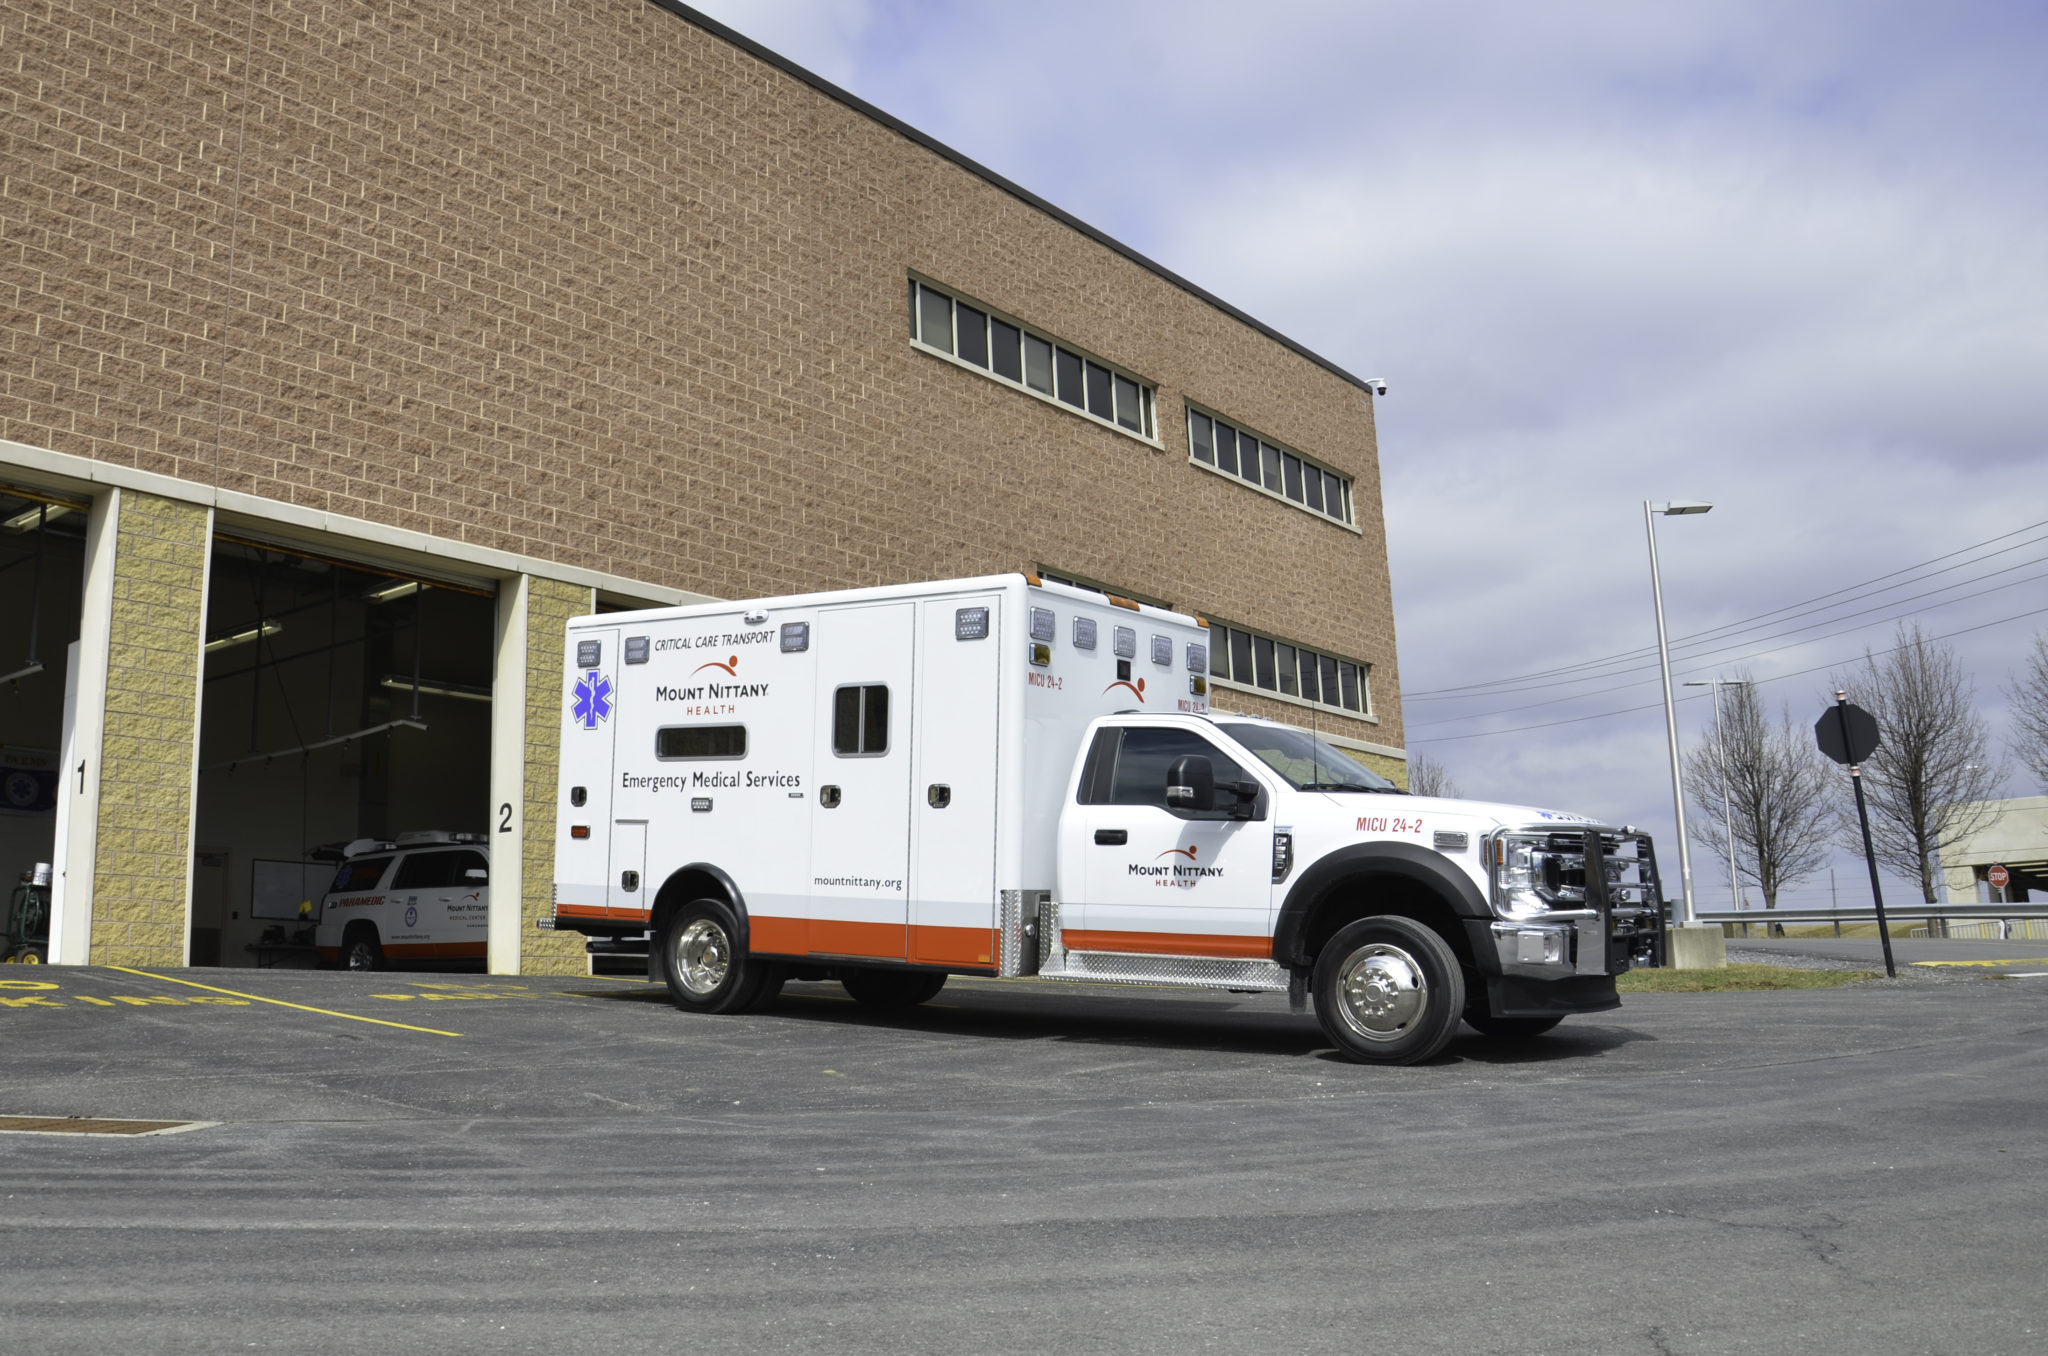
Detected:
[{"left": 0, "top": 0, "right": 1403, "bottom": 746}]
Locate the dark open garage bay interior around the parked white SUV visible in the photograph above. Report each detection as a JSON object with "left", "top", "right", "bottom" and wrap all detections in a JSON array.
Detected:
[{"left": 193, "top": 537, "right": 496, "bottom": 969}]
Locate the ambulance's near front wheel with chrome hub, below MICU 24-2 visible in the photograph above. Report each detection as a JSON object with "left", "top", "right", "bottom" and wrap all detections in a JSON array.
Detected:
[{"left": 1311, "top": 916, "right": 1464, "bottom": 1063}]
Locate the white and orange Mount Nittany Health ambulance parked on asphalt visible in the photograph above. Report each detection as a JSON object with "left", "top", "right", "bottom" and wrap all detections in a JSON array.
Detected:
[{"left": 541, "top": 576, "right": 1659, "bottom": 1063}]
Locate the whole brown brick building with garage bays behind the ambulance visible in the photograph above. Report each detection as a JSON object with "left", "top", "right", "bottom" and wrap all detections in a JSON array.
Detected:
[{"left": 0, "top": 0, "right": 1403, "bottom": 971}]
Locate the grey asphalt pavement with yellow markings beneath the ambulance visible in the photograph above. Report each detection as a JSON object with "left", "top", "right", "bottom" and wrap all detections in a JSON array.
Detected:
[{"left": 0, "top": 962, "right": 2048, "bottom": 1356}]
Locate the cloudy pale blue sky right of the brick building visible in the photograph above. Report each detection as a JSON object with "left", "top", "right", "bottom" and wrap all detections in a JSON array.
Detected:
[{"left": 700, "top": 0, "right": 2048, "bottom": 907}]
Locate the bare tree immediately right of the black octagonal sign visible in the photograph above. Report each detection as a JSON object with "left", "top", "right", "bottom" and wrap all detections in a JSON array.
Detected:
[{"left": 1833, "top": 623, "right": 2005, "bottom": 903}]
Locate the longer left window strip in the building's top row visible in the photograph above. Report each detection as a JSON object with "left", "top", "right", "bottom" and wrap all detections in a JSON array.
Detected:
[{"left": 909, "top": 279, "right": 1159, "bottom": 440}]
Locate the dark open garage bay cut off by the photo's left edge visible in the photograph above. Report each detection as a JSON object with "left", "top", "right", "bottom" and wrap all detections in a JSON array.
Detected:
[{"left": 0, "top": 485, "right": 86, "bottom": 961}]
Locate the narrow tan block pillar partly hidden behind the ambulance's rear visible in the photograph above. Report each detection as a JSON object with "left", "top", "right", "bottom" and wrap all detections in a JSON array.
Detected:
[{"left": 520, "top": 578, "right": 596, "bottom": 975}]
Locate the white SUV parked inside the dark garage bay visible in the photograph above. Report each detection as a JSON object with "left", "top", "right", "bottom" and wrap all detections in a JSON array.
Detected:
[{"left": 313, "top": 832, "right": 492, "bottom": 971}]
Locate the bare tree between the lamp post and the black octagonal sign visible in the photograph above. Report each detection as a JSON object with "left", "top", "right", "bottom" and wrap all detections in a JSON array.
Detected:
[{"left": 1686, "top": 674, "right": 1833, "bottom": 925}]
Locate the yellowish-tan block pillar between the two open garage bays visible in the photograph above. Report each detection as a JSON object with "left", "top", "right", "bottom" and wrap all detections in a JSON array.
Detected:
[{"left": 90, "top": 492, "right": 209, "bottom": 965}]
